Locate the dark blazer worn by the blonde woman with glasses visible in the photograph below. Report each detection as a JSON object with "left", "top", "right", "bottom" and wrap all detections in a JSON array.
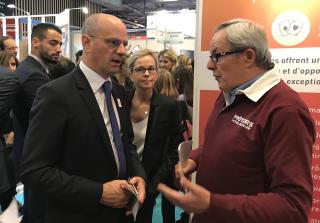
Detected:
[{"left": 128, "top": 90, "right": 183, "bottom": 194}]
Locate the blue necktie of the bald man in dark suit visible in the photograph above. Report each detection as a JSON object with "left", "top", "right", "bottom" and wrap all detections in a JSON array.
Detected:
[{"left": 102, "top": 81, "right": 126, "bottom": 178}]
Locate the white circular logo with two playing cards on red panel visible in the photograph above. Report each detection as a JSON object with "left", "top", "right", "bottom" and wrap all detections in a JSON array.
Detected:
[{"left": 272, "top": 11, "right": 310, "bottom": 46}]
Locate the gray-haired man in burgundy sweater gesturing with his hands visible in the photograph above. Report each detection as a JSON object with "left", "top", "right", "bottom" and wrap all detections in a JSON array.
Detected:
[{"left": 158, "top": 19, "right": 316, "bottom": 223}]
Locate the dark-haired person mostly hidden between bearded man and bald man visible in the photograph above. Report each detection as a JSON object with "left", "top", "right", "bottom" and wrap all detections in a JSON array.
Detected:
[{"left": 48, "top": 56, "right": 76, "bottom": 79}]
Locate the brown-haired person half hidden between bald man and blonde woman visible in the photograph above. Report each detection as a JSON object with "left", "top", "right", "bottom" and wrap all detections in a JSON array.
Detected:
[{"left": 111, "top": 54, "right": 133, "bottom": 90}]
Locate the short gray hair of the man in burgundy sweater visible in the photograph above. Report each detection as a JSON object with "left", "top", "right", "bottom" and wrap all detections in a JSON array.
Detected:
[{"left": 214, "top": 18, "right": 274, "bottom": 70}]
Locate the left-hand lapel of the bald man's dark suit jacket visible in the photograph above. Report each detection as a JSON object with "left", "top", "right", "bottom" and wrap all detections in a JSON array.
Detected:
[{"left": 73, "top": 67, "right": 116, "bottom": 162}]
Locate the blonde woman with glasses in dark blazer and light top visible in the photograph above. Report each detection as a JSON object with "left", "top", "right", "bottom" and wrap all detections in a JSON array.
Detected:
[{"left": 128, "top": 49, "right": 183, "bottom": 223}]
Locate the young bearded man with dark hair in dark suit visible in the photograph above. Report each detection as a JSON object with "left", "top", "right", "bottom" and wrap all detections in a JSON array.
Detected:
[{"left": 13, "top": 23, "right": 62, "bottom": 167}]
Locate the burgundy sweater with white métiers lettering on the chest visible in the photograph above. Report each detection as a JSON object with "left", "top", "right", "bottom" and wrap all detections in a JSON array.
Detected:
[{"left": 190, "top": 78, "right": 315, "bottom": 223}]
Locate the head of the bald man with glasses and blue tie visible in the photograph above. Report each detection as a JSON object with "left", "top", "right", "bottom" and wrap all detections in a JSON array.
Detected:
[{"left": 82, "top": 13, "right": 128, "bottom": 78}]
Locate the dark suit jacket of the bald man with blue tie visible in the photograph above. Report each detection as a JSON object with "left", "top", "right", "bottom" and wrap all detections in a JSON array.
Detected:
[{"left": 22, "top": 67, "right": 146, "bottom": 223}]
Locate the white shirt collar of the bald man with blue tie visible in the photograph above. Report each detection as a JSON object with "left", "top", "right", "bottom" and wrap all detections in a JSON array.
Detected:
[{"left": 79, "top": 60, "right": 112, "bottom": 94}]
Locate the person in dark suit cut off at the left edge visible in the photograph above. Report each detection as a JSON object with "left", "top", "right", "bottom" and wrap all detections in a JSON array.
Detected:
[{"left": 0, "top": 67, "right": 19, "bottom": 210}]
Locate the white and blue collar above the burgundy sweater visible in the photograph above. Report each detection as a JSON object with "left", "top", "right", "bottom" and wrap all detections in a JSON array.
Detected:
[{"left": 223, "top": 70, "right": 281, "bottom": 106}]
